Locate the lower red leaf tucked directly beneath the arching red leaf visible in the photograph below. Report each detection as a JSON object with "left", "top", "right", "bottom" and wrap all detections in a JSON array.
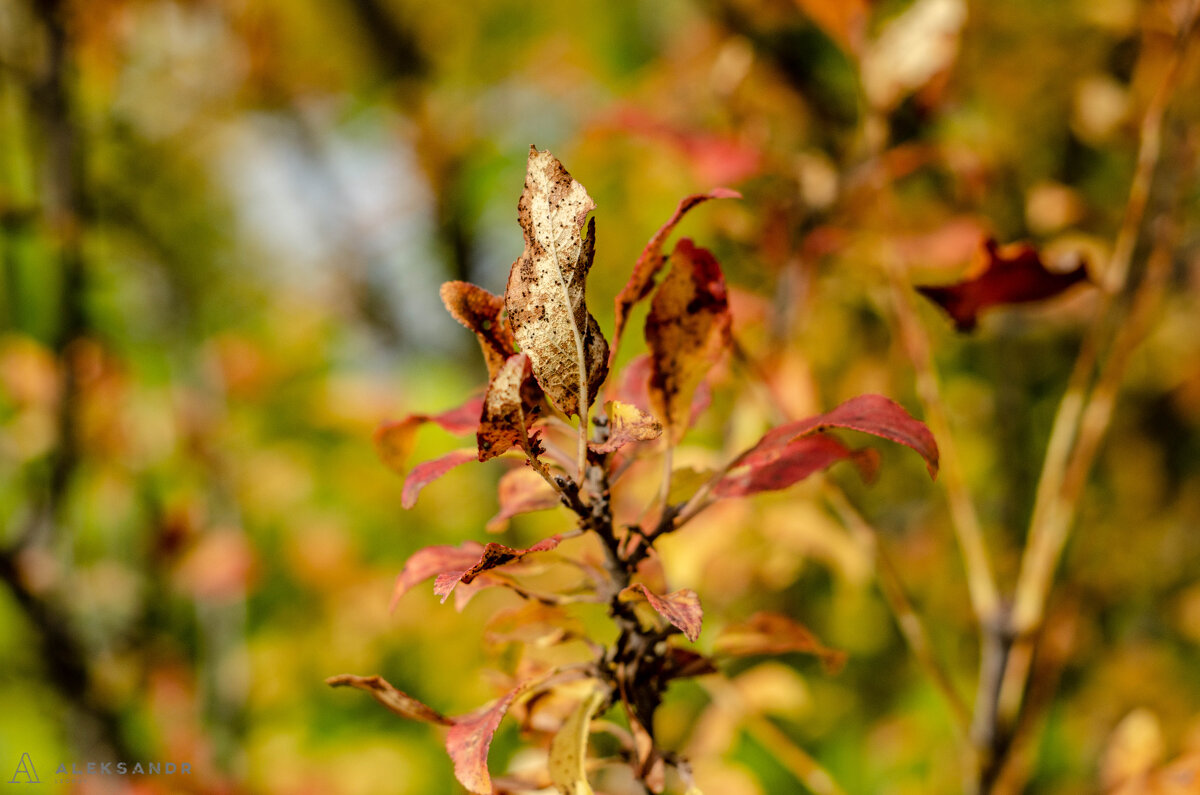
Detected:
[{"left": 713, "top": 434, "right": 878, "bottom": 497}]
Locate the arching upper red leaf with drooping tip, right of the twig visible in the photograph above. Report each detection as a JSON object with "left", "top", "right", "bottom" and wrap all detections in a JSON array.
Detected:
[{"left": 739, "top": 395, "right": 937, "bottom": 477}]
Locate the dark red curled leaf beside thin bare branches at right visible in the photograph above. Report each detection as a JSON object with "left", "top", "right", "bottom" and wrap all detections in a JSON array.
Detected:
[{"left": 917, "top": 238, "right": 1087, "bottom": 331}]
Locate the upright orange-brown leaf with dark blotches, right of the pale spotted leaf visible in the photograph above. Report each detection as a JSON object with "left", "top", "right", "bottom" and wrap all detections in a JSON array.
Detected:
[{"left": 646, "top": 238, "right": 730, "bottom": 442}]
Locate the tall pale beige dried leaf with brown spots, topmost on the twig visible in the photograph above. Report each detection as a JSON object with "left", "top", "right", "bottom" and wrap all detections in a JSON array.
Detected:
[{"left": 504, "top": 147, "right": 608, "bottom": 416}]
